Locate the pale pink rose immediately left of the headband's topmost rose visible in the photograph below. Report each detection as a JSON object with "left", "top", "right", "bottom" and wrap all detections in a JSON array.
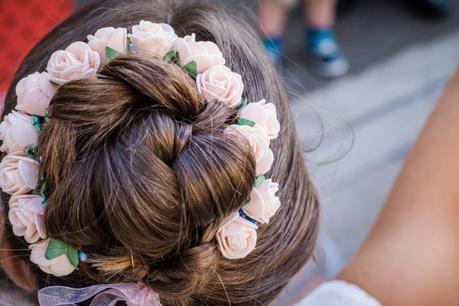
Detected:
[{"left": 88, "top": 27, "right": 127, "bottom": 63}]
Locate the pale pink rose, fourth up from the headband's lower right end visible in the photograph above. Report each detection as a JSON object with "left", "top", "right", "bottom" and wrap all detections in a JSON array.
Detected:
[{"left": 239, "top": 99, "right": 280, "bottom": 139}]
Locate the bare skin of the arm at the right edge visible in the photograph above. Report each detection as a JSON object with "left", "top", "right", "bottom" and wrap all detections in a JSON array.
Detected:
[{"left": 337, "top": 71, "right": 459, "bottom": 306}]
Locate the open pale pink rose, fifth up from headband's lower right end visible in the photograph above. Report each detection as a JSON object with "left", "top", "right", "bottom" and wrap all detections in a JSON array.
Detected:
[{"left": 196, "top": 65, "right": 244, "bottom": 107}]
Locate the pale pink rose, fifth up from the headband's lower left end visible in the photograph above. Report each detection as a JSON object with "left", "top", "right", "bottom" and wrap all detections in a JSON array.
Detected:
[{"left": 16, "top": 72, "right": 56, "bottom": 117}]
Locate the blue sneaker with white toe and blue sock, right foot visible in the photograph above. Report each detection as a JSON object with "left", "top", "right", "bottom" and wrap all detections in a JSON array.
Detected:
[{"left": 306, "top": 29, "right": 349, "bottom": 78}]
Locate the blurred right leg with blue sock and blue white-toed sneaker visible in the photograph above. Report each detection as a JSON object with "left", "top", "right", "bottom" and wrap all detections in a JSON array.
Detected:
[{"left": 305, "top": 0, "right": 349, "bottom": 77}]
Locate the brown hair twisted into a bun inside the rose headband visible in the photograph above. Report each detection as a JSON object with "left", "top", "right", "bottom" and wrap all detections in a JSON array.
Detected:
[{"left": 1, "top": 0, "right": 318, "bottom": 305}]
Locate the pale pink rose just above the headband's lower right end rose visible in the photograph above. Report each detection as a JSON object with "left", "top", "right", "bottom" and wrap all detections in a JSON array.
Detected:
[{"left": 244, "top": 179, "right": 280, "bottom": 223}]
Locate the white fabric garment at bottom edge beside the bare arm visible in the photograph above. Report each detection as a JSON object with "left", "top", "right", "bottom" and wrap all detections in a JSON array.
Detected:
[{"left": 295, "top": 280, "right": 381, "bottom": 306}]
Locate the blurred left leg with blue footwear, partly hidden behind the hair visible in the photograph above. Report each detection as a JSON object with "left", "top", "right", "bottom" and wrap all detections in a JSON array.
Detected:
[{"left": 257, "top": 0, "right": 295, "bottom": 65}]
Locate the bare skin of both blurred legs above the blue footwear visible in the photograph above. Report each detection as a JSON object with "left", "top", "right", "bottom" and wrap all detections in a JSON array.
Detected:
[{"left": 257, "top": 0, "right": 336, "bottom": 37}]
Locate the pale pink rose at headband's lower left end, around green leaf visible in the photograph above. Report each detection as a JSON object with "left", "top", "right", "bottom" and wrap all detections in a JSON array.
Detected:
[{"left": 29, "top": 239, "right": 75, "bottom": 277}]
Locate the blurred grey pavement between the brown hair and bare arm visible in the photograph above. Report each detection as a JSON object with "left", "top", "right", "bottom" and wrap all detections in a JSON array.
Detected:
[{"left": 273, "top": 0, "right": 459, "bottom": 306}]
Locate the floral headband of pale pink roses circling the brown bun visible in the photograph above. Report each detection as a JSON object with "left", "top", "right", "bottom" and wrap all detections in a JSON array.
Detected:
[{"left": 0, "top": 20, "right": 280, "bottom": 298}]
